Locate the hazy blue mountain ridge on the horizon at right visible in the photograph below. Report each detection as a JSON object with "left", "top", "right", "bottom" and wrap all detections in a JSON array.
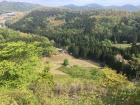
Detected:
[{"left": 63, "top": 4, "right": 140, "bottom": 11}]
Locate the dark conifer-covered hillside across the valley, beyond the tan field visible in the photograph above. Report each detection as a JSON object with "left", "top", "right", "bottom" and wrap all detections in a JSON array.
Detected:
[{"left": 7, "top": 9, "right": 140, "bottom": 79}]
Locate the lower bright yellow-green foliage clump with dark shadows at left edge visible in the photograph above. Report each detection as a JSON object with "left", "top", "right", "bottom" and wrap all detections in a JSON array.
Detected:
[{"left": 0, "top": 61, "right": 20, "bottom": 88}]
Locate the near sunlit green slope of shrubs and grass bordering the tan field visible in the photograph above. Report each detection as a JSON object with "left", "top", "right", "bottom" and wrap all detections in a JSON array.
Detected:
[{"left": 0, "top": 29, "right": 140, "bottom": 105}]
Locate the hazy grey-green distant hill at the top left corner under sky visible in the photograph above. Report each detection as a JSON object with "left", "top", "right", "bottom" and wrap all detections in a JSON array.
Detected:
[{"left": 0, "top": 1, "right": 41, "bottom": 13}]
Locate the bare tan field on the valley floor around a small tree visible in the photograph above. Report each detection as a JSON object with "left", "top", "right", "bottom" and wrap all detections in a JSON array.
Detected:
[{"left": 42, "top": 53, "right": 99, "bottom": 76}]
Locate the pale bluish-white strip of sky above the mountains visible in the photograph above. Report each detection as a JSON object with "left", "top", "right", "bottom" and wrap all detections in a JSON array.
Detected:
[{"left": 0, "top": 0, "right": 140, "bottom": 6}]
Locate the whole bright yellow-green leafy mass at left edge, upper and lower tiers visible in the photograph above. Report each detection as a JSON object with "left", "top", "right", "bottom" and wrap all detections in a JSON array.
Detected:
[{"left": 0, "top": 42, "right": 39, "bottom": 88}]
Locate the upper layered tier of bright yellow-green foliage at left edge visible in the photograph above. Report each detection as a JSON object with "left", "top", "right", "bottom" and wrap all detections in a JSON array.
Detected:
[{"left": 0, "top": 42, "right": 37, "bottom": 61}]
